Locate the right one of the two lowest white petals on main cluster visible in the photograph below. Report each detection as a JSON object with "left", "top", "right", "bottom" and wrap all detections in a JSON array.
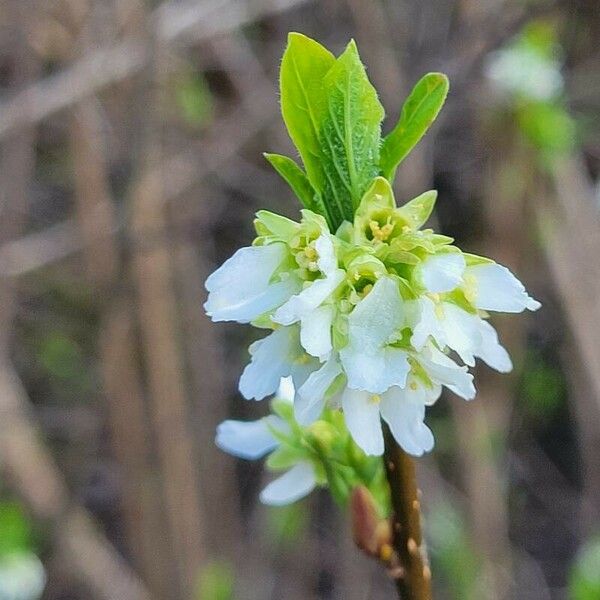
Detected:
[{"left": 380, "top": 382, "right": 434, "bottom": 456}]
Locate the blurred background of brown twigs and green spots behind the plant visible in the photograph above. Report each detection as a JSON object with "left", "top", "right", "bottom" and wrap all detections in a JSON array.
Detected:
[{"left": 0, "top": 0, "right": 600, "bottom": 600}]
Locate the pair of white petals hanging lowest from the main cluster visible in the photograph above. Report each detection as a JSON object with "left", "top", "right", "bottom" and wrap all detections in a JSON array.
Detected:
[{"left": 342, "top": 375, "right": 440, "bottom": 456}]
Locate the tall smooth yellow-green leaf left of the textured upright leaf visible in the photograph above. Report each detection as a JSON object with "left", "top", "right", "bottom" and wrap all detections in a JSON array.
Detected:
[{"left": 280, "top": 33, "right": 335, "bottom": 195}]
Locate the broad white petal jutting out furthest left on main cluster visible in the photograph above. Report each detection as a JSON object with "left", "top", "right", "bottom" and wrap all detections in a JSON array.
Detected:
[{"left": 204, "top": 242, "right": 300, "bottom": 323}]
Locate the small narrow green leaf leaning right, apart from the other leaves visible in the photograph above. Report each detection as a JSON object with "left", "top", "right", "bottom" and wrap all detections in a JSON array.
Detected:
[{"left": 380, "top": 73, "right": 450, "bottom": 181}]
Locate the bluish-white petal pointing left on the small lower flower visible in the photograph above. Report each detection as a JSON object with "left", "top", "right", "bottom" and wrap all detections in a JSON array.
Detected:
[{"left": 215, "top": 416, "right": 287, "bottom": 460}]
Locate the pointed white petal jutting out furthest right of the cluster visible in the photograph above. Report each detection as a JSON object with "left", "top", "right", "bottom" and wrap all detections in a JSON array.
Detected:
[{"left": 467, "top": 264, "right": 541, "bottom": 313}]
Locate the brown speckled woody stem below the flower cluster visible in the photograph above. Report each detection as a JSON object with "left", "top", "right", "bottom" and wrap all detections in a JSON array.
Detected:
[{"left": 383, "top": 424, "right": 432, "bottom": 600}]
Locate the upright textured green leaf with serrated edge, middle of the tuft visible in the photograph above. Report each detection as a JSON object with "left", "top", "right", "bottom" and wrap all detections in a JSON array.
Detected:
[{"left": 320, "top": 41, "right": 384, "bottom": 225}]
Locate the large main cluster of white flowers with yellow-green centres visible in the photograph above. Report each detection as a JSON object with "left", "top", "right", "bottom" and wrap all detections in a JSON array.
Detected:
[{"left": 205, "top": 177, "right": 540, "bottom": 458}]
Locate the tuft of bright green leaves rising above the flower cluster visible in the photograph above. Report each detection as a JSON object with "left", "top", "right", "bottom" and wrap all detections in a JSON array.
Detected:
[{"left": 274, "top": 33, "right": 448, "bottom": 232}]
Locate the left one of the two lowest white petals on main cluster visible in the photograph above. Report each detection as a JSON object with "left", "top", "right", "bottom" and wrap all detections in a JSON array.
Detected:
[{"left": 342, "top": 388, "right": 383, "bottom": 456}]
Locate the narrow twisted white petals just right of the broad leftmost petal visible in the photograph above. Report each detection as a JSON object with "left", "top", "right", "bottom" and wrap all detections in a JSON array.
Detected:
[{"left": 273, "top": 233, "right": 345, "bottom": 357}]
